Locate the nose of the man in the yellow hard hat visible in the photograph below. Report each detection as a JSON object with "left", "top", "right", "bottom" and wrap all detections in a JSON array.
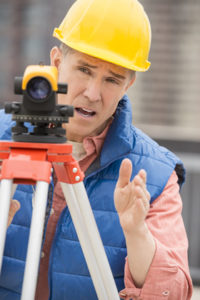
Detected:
[{"left": 83, "top": 78, "right": 101, "bottom": 102}]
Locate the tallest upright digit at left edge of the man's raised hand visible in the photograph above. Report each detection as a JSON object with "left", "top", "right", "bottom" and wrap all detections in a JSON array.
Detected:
[{"left": 117, "top": 158, "right": 132, "bottom": 188}]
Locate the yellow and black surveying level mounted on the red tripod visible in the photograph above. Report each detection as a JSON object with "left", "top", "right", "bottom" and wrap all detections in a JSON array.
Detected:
[{"left": 5, "top": 65, "right": 73, "bottom": 143}]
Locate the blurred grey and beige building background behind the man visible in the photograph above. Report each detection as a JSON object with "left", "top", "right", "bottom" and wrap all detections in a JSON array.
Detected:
[{"left": 0, "top": 0, "right": 200, "bottom": 299}]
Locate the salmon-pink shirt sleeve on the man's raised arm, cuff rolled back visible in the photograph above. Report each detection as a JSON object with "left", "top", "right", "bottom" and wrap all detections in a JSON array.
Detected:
[{"left": 120, "top": 172, "right": 192, "bottom": 300}]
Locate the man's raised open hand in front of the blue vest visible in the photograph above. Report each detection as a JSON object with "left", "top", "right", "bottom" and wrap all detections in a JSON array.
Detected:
[{"left": 114, "top": 159, "right": 150, "bottom": 233}]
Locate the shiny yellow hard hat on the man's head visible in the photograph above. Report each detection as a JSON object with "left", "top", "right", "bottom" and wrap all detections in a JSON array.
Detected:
[{"left": 53, "top": 0, "right": 151, "bottom": 72}]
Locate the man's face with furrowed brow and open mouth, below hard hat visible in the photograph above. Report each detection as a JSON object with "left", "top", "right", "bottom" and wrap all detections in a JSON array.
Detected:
[{"left": 51, "top": 47, "right": 134, "bottom": 142}]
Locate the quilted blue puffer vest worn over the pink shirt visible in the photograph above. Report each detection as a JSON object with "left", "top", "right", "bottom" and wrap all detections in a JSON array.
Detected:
[{"left": 0, "top": 97, "right": 184, "bottom": 300}]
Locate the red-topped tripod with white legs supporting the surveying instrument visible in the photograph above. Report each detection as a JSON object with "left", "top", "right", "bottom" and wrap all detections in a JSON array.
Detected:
[{"left": 0, "top": 141, "right": 119, "bottom": 300}]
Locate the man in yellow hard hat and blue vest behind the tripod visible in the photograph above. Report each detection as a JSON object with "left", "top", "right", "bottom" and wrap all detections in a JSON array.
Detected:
[{"left": 0, "top": 0, "right": 192, "bottom": 300}]
